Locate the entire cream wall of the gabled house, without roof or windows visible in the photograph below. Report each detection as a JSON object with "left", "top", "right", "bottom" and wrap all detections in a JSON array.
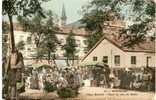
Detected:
[{"left": 81, "top": 39, "right": 155, "bottom": 68}]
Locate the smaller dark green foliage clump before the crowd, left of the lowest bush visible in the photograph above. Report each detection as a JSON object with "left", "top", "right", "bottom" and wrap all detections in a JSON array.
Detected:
[{"left": 44, "top": 81, "right": 57, "bottom": 92}]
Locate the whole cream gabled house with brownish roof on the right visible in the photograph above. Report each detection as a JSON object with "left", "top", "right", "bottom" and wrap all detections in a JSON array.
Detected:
[{"left": 81, "top": 36, "right": 155, "bottom": 68}]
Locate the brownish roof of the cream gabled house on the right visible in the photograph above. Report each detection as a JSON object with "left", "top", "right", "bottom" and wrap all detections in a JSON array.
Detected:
[{"left": 82, "top": 36, "right": 155, "bottom": 61}]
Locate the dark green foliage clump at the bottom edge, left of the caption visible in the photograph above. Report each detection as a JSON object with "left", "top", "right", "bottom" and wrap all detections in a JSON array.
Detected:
[{"left": 57, "top": 87, "right": 77, "bottom": 98}]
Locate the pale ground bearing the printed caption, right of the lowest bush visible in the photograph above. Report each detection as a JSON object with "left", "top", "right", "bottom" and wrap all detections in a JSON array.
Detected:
[{"left": 79, "top": 87, "right": 154, "bottom": 100}]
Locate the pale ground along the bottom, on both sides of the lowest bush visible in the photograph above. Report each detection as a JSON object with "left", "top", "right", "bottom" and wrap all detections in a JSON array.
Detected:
[{"left": 20, "top": 87, "right": 156, "bottom": 100}]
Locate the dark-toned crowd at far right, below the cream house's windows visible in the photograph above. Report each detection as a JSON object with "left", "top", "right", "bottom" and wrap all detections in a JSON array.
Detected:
[{"left": 118, "top": 68, "right": 155, "bottom": 91}]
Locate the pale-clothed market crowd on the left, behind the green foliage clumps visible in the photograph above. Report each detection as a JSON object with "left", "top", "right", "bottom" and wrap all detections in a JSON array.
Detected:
[{"left": 26, "top": 67, "right": 83, "bottom": 90}]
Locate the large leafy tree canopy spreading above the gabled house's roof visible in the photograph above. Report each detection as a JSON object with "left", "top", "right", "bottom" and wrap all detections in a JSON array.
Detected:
[{"left": 81, "top": 0, "right": 155, "bottom": 49}]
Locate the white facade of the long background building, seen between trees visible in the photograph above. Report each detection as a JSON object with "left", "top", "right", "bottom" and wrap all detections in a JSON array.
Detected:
[{"left": 14, "top": 30, "right": 86, "bottom": 58}]
